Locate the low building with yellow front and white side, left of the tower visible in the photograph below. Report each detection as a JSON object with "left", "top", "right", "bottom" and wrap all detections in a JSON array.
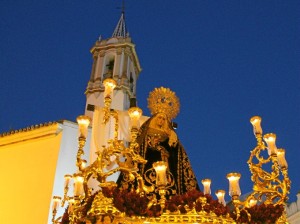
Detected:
[{"left": 0, "top": 121, "right": 90, "bottom": 224}]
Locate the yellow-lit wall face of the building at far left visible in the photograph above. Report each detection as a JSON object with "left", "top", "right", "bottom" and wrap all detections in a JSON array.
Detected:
[{"left": 0, "top": 123, "right": 62, "bottom": 224}]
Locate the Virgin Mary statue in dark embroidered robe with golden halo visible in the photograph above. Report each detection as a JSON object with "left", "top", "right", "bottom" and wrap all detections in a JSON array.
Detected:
[{"left": 118, "top": 87, "right": 199, "bottom": 196}]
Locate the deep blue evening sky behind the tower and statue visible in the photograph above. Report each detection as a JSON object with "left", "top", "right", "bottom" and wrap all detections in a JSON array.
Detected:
[{"left": 0, "top": 0, "right": 300, "bottom": 201}]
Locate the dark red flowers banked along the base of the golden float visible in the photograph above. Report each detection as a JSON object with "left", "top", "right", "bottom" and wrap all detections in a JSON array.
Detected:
[{"left": 61, "top": 188, "right": 284, "bottom": 224}]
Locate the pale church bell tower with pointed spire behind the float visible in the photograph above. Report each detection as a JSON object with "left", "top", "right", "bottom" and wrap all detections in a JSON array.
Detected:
[{"left": 85, "top": 10, "right": 141, "bottom": 118}]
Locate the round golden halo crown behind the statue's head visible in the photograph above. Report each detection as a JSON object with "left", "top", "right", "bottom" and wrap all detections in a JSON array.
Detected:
[{"left": 148, "top": 87, "right": 180, "bottom": 120}]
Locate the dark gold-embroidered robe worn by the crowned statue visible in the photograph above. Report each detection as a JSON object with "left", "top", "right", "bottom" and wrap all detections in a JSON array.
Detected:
[{"left": 118, "top": 117, "right": 199, "bottom": 196}]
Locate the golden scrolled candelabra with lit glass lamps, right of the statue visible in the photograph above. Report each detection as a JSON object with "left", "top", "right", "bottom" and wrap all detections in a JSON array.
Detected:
[{"left": 227, "top": 116, "right": 291, "bottom": 223}]
